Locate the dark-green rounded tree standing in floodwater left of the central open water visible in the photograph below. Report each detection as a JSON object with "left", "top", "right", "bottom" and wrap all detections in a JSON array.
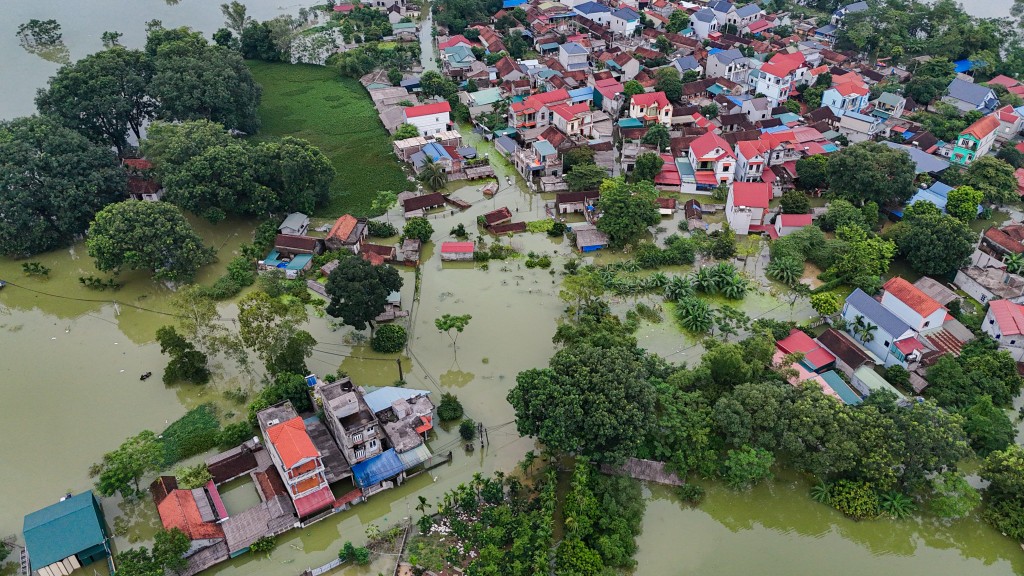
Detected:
[{"left": 326, "top": 256, "right": 402, "bottom": 333}]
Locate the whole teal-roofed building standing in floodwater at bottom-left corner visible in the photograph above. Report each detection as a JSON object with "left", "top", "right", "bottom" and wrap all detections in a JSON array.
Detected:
[{"left": 24, "top": 491, "right": 111, "bottom": 576}]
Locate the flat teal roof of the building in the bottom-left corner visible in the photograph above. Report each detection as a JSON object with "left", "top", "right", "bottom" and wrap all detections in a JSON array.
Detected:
[{"left": 23, "top": 491, "right": 105, "bottom": 571}]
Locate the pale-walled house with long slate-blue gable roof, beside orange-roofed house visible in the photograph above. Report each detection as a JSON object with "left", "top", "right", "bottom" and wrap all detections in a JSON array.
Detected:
[{"left": 843, "top": 288, "right": 924, "bottom": 368}]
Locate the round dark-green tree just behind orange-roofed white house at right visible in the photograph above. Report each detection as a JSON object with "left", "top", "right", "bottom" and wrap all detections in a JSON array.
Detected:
[{"left": 898, "top": 215, "right": 977, "bottom": 276}]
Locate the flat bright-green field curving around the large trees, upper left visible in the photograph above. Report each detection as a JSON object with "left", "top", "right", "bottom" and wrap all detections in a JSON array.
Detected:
[{"left": 247, "top": 60, "right": 414, "bottom": 217}]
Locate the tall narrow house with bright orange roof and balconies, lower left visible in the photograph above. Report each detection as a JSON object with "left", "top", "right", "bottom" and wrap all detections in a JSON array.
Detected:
[{"left": 256, "top": 401, "right": 335, "bottom": 518}]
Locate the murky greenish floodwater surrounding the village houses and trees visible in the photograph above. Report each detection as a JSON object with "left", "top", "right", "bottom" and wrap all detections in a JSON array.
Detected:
[{"left": 0, "top": 0, "right": 1024, "bottom": 576}]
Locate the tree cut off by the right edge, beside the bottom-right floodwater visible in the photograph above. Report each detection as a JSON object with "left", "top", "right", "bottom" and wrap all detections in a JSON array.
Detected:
[{"left": 981, "top": 445, "right": 1024, "bottom": 540}]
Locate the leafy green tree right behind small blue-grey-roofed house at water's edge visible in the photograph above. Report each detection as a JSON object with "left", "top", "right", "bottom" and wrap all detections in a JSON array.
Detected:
[{"left": 597, "top": 176, "right": 662, "bottom": 247}]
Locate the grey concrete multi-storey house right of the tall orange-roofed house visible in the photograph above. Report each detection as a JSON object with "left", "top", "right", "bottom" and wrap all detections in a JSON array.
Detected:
[{"left": 313, "top": 378, "right": 384, "bottom": 466}]
